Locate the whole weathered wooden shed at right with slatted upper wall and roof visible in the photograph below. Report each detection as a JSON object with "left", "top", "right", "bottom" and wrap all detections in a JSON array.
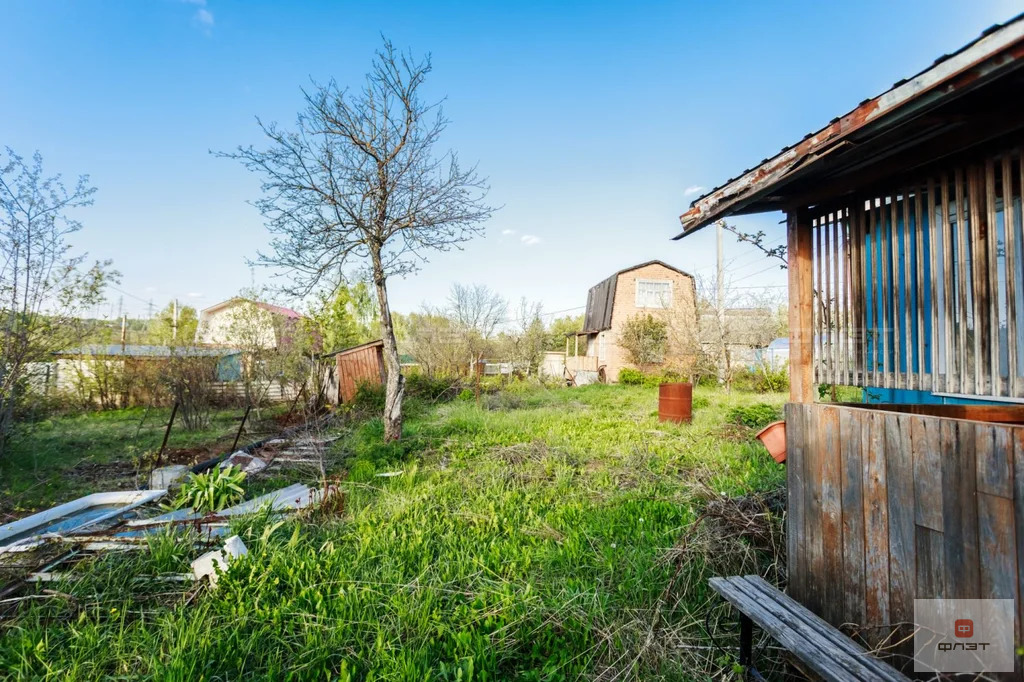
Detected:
[{"left": 677, "top": 15, "right": 1024, "bottom": 679}]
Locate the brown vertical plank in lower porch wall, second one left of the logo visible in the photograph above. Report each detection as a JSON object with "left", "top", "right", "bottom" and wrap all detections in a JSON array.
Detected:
[{"left": 863, "top": 412, "right": 891, "bottom": 626}]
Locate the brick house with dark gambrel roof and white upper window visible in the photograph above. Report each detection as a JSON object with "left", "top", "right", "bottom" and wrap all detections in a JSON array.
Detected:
[{"left": 566, "top": 260, "right": 696, "bottom": 382}]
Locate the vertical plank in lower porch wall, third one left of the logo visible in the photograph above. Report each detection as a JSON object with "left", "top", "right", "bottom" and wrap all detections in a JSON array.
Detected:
[{"left": 839, "top": 409, "right": 867, "bottom": 623}]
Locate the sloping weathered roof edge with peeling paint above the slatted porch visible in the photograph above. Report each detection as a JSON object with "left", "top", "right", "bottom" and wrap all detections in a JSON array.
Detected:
[{"left": 675, "top": 13, "right": 1024, "bottom": 240}]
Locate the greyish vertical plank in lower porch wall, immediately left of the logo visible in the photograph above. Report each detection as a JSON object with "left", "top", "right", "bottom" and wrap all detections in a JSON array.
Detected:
[{"left": 885, "top": 414, "right": 920, "bottom": 623}]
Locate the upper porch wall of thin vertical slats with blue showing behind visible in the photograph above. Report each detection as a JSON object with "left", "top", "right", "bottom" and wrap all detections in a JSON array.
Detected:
[{"left": 811, "top": 144, "right": 1024, "bottom": 397}]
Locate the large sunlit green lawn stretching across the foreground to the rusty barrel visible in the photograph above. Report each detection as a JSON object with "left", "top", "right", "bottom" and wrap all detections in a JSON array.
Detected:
[{"left": 0, "top": 385, "right": 784, "bottom": 681}]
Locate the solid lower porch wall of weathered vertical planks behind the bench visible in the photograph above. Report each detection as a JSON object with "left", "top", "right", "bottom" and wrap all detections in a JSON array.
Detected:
[{"left": 785, "top": 403, "right": 1024, "bottom": 664}]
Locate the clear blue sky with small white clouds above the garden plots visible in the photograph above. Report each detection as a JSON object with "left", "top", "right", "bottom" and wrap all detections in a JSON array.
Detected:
[{"left": 0, "top": 0, "right": 1021, "bottom": 314}]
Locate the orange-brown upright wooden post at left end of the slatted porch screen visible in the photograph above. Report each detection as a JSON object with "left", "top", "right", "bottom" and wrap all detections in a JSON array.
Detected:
[{"left": 786, "top": 211, "right": 814, "bottom": 402}]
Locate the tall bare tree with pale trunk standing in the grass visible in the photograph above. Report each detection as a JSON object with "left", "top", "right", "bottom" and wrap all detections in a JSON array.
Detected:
[{"left": 222, "top": 41, "right": 494, "bottom": 440}]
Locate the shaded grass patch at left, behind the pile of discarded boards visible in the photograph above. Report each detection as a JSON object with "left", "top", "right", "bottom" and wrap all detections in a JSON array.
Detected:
[{"left": 0, "top": 406, "right": 287, "bottom": 512}]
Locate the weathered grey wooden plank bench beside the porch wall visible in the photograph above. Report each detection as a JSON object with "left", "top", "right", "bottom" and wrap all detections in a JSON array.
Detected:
[{"left": 711, "top": 576, "right": 909, "bottom": 682}]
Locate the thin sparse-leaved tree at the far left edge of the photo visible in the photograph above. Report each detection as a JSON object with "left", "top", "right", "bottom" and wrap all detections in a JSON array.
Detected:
[{"left": 0, "top": 147, "right": 118, "bottom": 457}]
